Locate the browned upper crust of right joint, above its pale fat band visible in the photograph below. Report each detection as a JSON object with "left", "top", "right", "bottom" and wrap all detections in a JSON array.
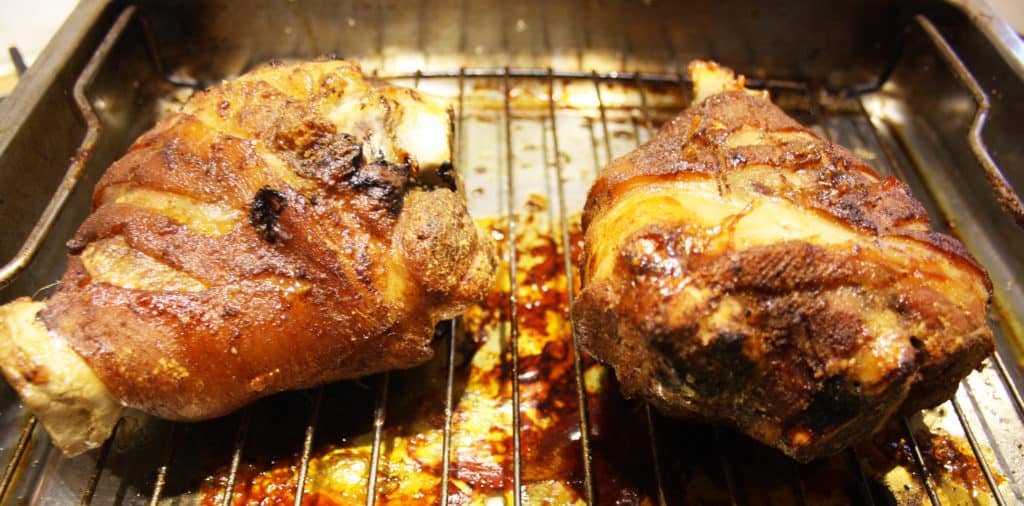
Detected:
[{"left": 584, "top": 91, "right": 988, "bottom": 283}]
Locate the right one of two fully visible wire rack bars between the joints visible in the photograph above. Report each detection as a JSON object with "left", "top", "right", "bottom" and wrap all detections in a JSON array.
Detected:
[{"left": 548, "top": 69, "right": 597, "bottom": 505}]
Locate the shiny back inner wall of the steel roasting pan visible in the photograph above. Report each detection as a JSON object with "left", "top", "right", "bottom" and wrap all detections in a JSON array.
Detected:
[{"left": 136, "top": 0, "right": 901, "bottom": 85}]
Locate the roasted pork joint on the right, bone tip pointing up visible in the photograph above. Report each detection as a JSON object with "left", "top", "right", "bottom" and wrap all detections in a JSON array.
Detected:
[{"left": 572, "top": 61, "right": 993, "bottom": 461}]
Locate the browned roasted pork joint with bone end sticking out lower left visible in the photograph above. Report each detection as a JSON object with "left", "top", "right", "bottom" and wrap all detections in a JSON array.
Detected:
[{"left": 0, "top": 60, "right": 496, "bottom": 454}]
